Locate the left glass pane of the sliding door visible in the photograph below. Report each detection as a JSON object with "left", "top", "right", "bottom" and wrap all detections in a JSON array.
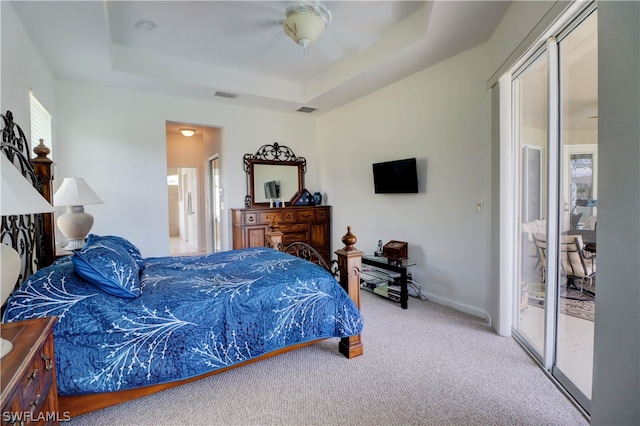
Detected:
[{"left": 512, "top": 52, "right": 549, "bottom": 358}]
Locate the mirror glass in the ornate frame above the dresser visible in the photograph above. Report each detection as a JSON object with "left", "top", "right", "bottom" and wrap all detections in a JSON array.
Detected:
[{"left": 253, "top": 164, "right": 298, "bottom": 203}]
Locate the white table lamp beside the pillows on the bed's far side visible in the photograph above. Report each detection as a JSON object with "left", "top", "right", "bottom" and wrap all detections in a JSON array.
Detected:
[{"left": 53, "top": 177, "right": 104, "bottom": 250}]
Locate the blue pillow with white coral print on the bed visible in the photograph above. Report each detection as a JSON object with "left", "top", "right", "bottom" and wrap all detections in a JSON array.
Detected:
[{"left": 71, "top": 239, "right": 140, "bottom": 299}]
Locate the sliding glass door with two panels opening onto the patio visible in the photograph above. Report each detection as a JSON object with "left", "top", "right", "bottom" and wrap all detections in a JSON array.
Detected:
[{"left": 512, "top": 6, "right": 598, "bottom": 412}]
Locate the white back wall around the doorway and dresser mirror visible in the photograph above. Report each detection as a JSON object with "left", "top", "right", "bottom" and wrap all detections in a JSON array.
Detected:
[{"left": 56, "top": 82, "right": 318, "bottom": 256}]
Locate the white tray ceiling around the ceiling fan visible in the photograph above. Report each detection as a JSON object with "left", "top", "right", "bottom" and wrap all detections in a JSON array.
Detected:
[{"left": 12, "top": 0, "right": 510, "bottom": 114}]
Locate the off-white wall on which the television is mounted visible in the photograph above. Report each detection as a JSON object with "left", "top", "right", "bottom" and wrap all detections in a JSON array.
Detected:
[{"left": 317, "top": 45, "right": 494, "bottom": 318}]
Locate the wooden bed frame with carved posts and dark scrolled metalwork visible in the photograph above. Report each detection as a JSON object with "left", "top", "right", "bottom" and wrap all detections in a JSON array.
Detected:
[{"left": 0, "top": 111, "right": 364, "bottom": 417}]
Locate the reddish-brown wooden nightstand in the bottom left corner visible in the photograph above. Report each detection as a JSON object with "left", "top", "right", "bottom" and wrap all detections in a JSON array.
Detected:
[{"left": 0, "top": 317, "right": 61, "bottom": 425}]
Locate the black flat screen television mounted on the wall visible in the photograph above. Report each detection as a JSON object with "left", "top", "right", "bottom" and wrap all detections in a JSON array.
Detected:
[{"left": 373, "top": 158, "right": 418, "bottom": 194}]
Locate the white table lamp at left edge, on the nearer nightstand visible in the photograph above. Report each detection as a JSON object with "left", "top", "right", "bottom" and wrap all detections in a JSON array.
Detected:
[{"left": 0, "top": 153, "right": 53, "bottom": 357}]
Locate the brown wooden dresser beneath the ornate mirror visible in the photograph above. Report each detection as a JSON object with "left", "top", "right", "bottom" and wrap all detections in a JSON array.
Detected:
[{"left": 231, "top": 206, "right": 331, "bottom": 263}]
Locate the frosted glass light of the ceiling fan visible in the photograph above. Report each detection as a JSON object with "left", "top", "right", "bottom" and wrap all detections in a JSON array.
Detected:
[{"left": 282, "top": 2, "right": 331, "bottom": 56}]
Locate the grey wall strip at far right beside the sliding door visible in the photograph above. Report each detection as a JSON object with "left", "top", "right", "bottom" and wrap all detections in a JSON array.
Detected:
[{"left": 591, "top": 1, "right": 640, "bottom": 425}]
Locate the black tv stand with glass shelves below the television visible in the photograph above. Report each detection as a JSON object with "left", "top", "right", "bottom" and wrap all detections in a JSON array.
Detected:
[{"left": 360, "top": 254, "right": 416, "bottom": 309}]
